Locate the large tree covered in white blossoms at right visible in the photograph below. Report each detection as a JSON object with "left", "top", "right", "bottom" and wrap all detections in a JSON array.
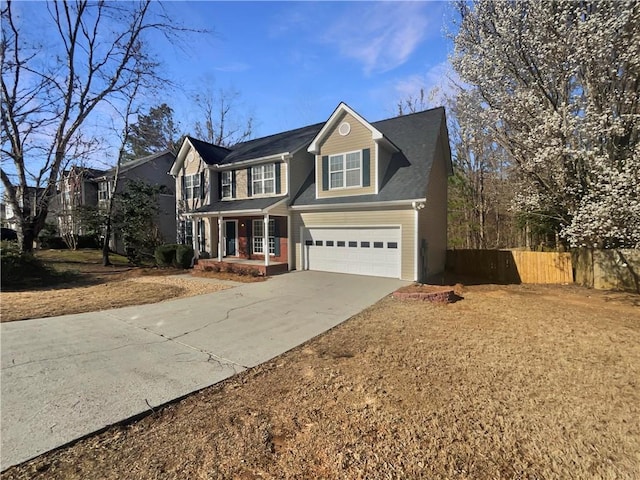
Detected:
[{"left": 452, "top": 0, "right": 640, "bottom": 248}]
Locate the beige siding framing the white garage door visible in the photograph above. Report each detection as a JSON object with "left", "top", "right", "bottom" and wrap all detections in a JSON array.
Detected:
[{"left": 290, "top": 207, "right": 415, "bottom": 280}]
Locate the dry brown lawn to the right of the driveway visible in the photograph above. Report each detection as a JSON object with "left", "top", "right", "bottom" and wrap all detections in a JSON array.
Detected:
[{"left": 3, "top": 286, "right": 640, "bottom": 480}]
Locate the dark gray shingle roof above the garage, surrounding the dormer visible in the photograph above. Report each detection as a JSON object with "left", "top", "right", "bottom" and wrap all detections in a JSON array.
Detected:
[{"left": 291, "top": 107, "right": 448, "bottom": 206}]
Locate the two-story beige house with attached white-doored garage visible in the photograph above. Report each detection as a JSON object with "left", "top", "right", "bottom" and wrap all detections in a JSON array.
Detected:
[{"left": 170, "top": 103, "right": 452, "bottom": 281}]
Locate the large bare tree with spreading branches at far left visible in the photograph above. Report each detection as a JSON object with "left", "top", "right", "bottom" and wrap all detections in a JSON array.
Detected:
[{"left": 0, "top": 0, "right": 186, "bottom": 252}]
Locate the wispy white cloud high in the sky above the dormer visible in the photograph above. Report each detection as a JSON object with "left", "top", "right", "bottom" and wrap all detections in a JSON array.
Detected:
[{"left": 323, "top": 2, "right": 432, "bottom": 75}]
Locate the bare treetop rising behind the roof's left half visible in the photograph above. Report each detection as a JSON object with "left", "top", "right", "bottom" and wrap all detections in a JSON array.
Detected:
[{"left": 194, "top": 89, "right": 253, "bottom": 147}]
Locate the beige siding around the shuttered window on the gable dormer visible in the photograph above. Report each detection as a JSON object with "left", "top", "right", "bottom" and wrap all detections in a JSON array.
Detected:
[{"left": 316, "top": 113, "right": 378, "bottom": 198}]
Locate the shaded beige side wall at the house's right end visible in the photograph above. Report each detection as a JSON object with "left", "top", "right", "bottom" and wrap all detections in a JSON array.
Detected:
[{"left": 419, "top": 137, "right": 447, "bottom": 277}]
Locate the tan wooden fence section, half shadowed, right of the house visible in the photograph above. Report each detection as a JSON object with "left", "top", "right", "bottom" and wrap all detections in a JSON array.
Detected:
[{"left": 447, "top": 250, "right": 573, "bottom": 283}]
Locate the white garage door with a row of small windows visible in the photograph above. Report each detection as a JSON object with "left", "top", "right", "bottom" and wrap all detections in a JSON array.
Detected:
[{"left": 302, "top": 227, "right": 400, "bottom": 278}]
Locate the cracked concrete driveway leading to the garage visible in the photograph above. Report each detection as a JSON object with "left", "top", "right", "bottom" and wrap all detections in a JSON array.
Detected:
[{"left": 0, "top": 272, "right": 407, "bottom": 470}]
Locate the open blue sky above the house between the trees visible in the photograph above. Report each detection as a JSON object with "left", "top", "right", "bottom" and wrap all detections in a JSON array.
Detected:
[{"left": 156, "top": 1, "right": 451, "bottom": 137}]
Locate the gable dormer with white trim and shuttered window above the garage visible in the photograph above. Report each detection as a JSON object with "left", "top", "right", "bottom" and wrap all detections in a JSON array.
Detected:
[{"left": 308, "top": 103, "right": 397, "bottom": 198}]
